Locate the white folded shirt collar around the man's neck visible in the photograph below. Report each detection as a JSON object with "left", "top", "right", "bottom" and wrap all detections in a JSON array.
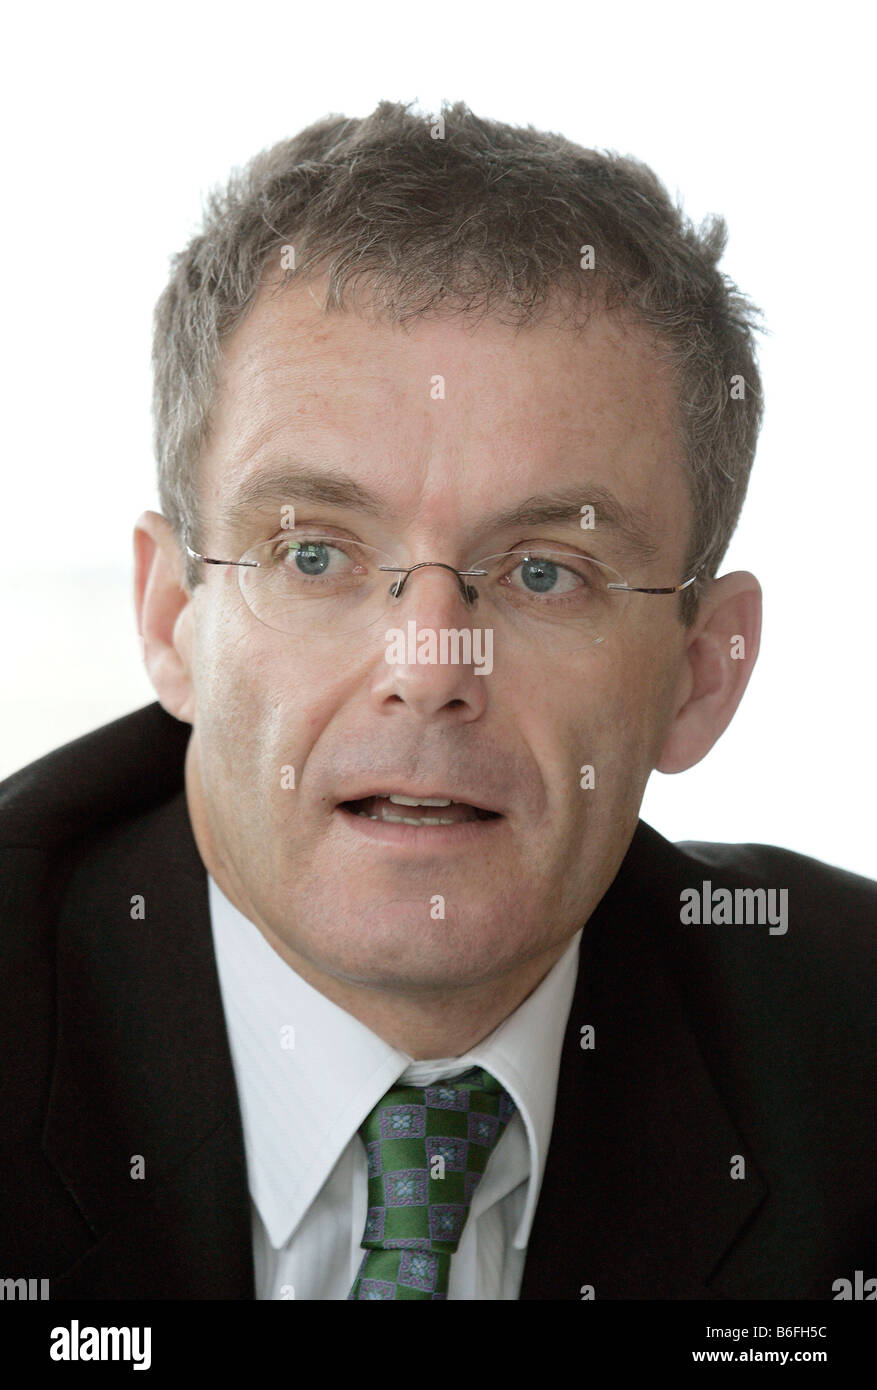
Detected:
[{"left": 207, "top": 874, "right": 581, "bottom": 1250}]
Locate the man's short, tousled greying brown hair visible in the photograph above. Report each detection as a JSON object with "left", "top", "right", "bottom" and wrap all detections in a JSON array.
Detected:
[{"left": 153, "top": 101, "right": 763, "bottom": 623}]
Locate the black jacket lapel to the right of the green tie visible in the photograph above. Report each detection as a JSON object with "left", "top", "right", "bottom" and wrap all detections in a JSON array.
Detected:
[{"left": 521, "top": 821, "right": 767, "bottom": 1300}]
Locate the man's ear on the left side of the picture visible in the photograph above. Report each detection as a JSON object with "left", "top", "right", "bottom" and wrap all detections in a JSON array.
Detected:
[{"left": 133, "top": 512, "right": 195, "bottom": 724}]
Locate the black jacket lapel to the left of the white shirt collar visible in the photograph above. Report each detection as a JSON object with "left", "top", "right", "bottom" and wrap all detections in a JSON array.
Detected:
[{"left": 43, "top": 792, "right": 253, "bottom": 1298}]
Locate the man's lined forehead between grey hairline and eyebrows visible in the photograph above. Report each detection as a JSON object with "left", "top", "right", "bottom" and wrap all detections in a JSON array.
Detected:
[{"left": 202, "top": 273, "right": 689, "bottom": 553}]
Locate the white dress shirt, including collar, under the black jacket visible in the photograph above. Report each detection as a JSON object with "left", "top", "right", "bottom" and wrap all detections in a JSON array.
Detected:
[{"left": 208, "top": 874, "right": 581, "bottom": 1300}]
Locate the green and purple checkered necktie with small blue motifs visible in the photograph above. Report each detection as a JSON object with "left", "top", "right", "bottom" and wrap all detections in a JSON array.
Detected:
[{"left": 347, "top": 1066, "right": 517, "bottom": 1300}]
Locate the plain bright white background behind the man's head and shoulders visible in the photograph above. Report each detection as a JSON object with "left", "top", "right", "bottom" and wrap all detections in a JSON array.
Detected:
[{"left": 0, "top": 0, "right": 877, "bottom": 877}]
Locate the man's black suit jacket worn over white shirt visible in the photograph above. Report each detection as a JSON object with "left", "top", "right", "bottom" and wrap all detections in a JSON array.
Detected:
[{"left": 0, "top": 703, "right": 877, "bottom": 1300}]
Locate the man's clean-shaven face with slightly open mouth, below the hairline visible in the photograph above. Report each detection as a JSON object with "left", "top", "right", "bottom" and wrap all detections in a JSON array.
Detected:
[{"left": 175, "top": 285, "right": 689, "bottom": 994}]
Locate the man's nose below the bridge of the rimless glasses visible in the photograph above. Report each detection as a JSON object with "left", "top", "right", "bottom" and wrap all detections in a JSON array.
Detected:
[{"left": 371, "top": 563, "right": 492, "bottom": 723}]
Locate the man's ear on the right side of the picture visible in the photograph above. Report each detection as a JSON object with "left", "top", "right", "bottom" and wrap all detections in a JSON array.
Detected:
[{"left": 655, "top": 570, "right": 762, "bottom": 773}]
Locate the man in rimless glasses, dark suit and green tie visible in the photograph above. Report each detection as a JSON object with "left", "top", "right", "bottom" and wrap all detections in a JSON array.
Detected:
[{"left": 1, "top": 103, "right": 877, "bottom": 1300}]
